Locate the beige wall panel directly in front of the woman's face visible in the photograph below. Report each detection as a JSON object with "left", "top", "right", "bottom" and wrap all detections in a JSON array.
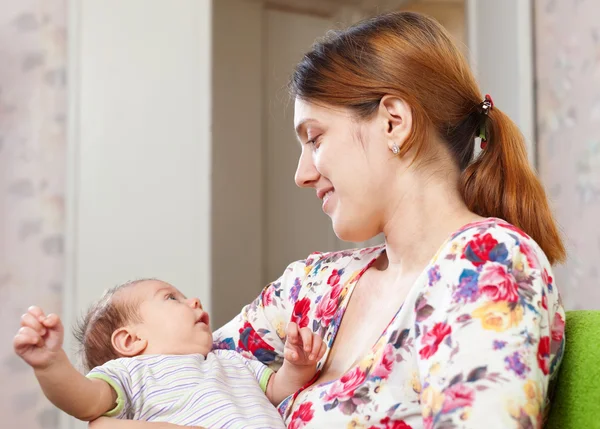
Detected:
[{"left": 264, "top": 10, "right": 338, "bottom": 281}]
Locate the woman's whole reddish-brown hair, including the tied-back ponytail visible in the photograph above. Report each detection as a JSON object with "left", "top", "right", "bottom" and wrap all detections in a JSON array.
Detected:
[{"left": 290, "top": 12, "right": 565, "bottom": 264}]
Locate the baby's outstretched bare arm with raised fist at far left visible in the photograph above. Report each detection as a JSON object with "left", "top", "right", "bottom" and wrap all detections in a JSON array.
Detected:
[{"left": 13, "top": 307, "right": 117, "bottom": 421}]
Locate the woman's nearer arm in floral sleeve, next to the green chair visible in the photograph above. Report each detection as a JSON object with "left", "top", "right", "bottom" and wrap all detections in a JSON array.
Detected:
[{"left": 415, "top": 226, "right": 564, "bottom": 429}]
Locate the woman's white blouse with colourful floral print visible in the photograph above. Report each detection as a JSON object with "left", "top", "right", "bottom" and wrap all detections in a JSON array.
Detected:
[{"left": 215, "top": 219, "right": 565, "bottom": 429}]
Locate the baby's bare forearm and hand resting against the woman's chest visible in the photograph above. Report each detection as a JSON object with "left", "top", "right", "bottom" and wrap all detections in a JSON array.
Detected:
[{"left": 266, "top": 322, "right": 327, "bottom": 405}]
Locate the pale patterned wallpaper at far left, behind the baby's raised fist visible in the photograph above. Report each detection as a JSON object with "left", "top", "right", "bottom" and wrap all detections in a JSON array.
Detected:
[{"left": 0, "top": 0, "right": 67, "bottom": 429}]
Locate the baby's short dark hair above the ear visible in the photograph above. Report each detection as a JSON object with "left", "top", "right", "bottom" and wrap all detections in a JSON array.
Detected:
[{"left": 73, "top": 279, "right": 155, "bottom": 371}]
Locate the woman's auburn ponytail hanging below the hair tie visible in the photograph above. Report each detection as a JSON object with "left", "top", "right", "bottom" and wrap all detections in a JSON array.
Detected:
[{"left": 461, "top": 108, "right": 566, "bottom": 264}]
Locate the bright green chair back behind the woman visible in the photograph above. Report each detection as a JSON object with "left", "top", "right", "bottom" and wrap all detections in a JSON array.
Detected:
[{"left": 545, "top": 311, "right": 600, "bottom": 429}]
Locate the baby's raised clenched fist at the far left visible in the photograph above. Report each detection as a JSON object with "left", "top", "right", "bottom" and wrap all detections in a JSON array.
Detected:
[{"left": 13, "top": 306, "right": 64, "bottom": 369}]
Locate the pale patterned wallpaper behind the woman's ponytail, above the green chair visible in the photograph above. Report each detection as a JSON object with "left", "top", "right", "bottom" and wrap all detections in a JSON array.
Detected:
[{"left": 535, "top": 0, "right": 600, "bottom": 309}]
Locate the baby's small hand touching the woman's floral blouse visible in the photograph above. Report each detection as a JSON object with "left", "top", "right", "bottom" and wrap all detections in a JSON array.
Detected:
[{"left": 283, "top": 322, "right": 327, "bottom": 366}]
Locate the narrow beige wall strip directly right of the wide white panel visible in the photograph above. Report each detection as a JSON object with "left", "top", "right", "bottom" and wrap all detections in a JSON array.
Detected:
[{"left": 211, "top": 0, "right": 265, "bottom": 326}]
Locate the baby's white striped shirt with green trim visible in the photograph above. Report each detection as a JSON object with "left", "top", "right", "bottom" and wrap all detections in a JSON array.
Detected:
[{"left": 88, "top": 350, "right": 285, "bottom": 429}]
